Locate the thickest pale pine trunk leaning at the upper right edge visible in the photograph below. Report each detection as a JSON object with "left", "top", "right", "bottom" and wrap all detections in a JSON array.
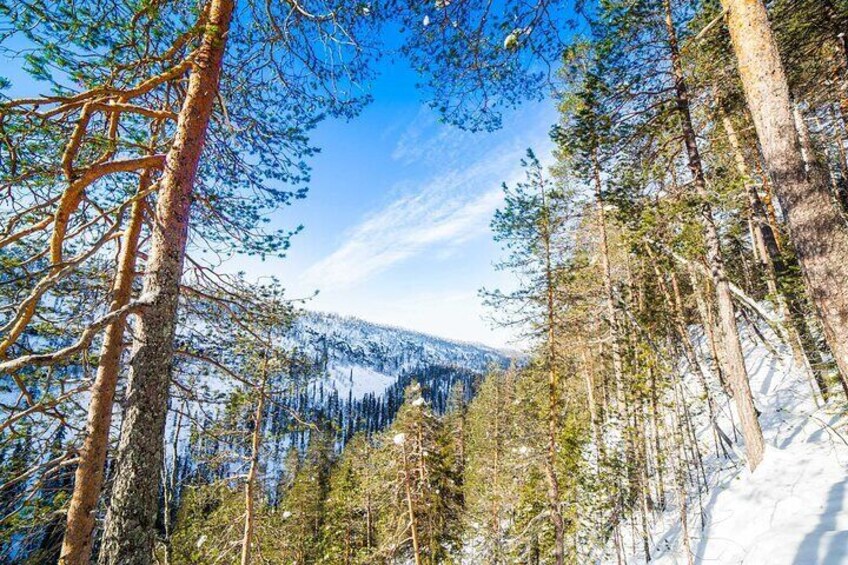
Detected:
[{"left": 722, "top": 0, "right": 848, "bottom": 386}]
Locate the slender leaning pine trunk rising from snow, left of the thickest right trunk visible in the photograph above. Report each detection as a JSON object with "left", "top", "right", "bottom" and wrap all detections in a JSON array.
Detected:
[{"left": 664, "top": 0, "right": 765, "bottom": 470}]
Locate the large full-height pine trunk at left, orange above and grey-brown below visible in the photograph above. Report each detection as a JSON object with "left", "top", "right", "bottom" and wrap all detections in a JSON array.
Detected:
[{"left": 100, "top": 0, "right": 234, "bottom": 565}]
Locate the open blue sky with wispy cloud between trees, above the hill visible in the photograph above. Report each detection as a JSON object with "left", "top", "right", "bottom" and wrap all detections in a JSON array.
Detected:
[{"left": 236, "top": 59, "right": 556, "bottom": 346}]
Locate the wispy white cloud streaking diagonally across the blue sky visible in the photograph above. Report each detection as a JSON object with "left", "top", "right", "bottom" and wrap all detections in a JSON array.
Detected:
[{"left": 305, "top": 106, "right": 549, "bottom": 290}]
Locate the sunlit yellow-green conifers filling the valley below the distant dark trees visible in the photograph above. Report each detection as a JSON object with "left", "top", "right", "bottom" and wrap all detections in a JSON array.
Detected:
[{"left": 164, "top": 370, "right": 588, "bottom": 564}]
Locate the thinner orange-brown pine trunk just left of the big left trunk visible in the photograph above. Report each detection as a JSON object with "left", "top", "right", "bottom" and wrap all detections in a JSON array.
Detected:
[{"left": 59, "top": 170, "right": 151, "bottom": 565}]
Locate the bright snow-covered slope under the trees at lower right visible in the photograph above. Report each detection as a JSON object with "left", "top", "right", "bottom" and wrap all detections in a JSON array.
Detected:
[{"left": 644, "top": 322, "right": 848, "bottom": 565}]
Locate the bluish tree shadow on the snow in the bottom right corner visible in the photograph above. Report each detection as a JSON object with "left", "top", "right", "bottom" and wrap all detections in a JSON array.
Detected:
[{"left": 793, "top": 479, "right": 848, "bottom": 565}]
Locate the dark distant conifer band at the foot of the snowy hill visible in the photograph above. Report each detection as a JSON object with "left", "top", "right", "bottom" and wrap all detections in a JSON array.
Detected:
[{"left": 169, "top": 365, "right": 480, "bottom": 508}]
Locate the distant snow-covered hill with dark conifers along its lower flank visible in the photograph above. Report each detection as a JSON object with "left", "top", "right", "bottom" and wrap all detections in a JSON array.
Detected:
[{"left": 172, "top": 312, "right": 510, "bottom": 496}]
